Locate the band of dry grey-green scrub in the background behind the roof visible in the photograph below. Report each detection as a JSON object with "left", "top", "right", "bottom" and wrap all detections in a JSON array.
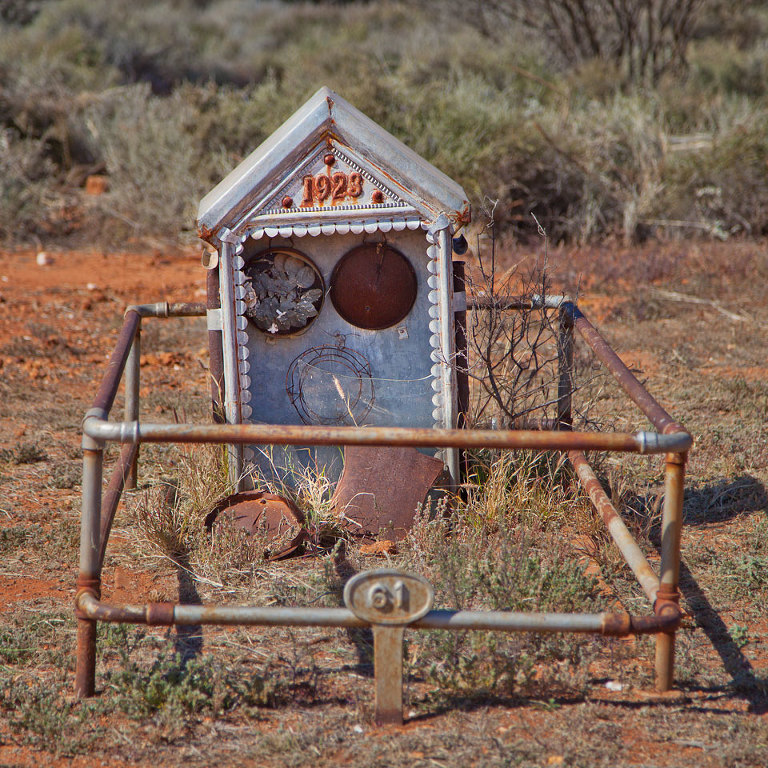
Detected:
[{"left": 0, "top": 0, "right": 768, "bottom": 242}]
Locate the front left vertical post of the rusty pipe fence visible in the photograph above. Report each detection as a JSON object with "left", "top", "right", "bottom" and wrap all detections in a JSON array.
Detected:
[{"left": 75, "top": 437, "right": 104, "bottom": 698}]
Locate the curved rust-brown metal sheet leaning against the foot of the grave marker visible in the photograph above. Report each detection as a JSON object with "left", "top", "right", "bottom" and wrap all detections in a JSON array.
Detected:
[{"left": 331, "top": 446, "right": 443, "bottom": 539}]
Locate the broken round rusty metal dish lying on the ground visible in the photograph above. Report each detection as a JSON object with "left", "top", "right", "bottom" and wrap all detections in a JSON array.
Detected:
[{"left": 205, "top": 491, "right": 307, "bottom": 560}]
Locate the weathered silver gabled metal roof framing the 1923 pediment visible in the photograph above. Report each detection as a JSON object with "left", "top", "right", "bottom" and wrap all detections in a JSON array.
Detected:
[{"left": 198, "top": 88, "right": 469, "bottom": 243}]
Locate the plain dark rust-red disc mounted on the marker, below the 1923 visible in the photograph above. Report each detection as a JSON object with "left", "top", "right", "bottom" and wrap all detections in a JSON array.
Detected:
[{"left": 331, "top": 243, "right": 416, "bottom": 330}]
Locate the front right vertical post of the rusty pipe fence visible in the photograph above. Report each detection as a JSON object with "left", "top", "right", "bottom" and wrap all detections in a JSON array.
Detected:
[{"left": 654, "top": 453, "right": 687, "bottom": 691}]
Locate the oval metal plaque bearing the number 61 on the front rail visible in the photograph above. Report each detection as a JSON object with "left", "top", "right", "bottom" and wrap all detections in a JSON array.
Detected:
[{"left": 344, "top": 568, "right": 435, "bottom": 625}]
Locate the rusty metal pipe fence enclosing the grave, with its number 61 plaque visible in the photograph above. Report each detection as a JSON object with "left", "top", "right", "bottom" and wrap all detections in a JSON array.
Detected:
[{"left": 75, "top": 296, "right": 692, "bottom": 723}]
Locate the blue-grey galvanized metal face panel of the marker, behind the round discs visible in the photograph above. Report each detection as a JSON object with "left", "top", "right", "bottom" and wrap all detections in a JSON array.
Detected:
[{"left": 243, "top": 230, "right": 436, "bottom": 486}]
